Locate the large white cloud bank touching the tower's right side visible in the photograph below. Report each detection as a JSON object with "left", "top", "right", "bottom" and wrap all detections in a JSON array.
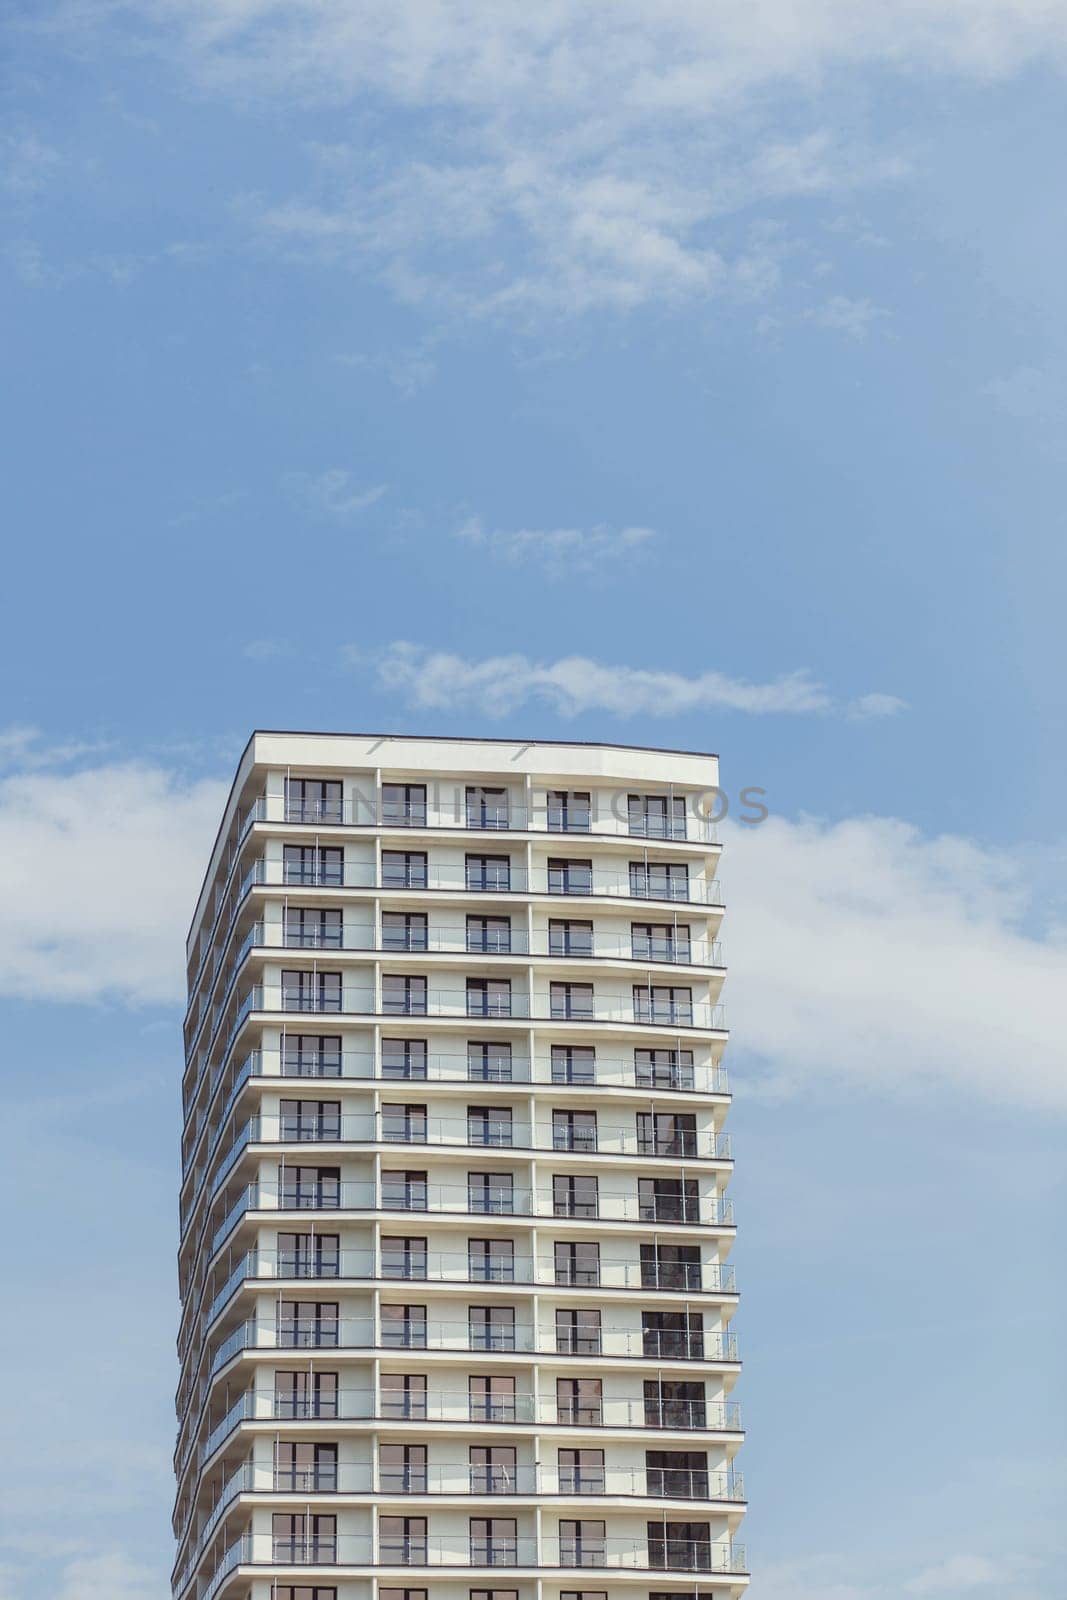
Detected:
[{"left": 723, "top": 812, "right": 1067, "bottom": 1110}]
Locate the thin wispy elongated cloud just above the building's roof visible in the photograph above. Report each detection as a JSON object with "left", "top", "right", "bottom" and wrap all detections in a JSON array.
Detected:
[{"left": 351, "top": 640, "right": 899, "bottom": 717}]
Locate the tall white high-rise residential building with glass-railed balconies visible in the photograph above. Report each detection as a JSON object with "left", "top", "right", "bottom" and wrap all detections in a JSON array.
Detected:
[{"left": 174, "top": 733, "right": 747, "bottom": 1600}]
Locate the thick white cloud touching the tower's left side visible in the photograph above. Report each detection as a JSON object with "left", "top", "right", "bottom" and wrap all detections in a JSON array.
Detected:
[{"left": 0, "top": 762, "right": 226, "bottom": 1003}]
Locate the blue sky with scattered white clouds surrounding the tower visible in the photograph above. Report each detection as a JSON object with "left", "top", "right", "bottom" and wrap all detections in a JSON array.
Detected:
[{"left": 0, "top": 0, "right": 1067, "bottom": 1600}]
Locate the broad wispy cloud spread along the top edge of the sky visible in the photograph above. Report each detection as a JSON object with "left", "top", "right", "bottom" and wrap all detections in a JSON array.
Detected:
[{"left": 85, "top": 0, "right": 1067, "bottom": 318}]
